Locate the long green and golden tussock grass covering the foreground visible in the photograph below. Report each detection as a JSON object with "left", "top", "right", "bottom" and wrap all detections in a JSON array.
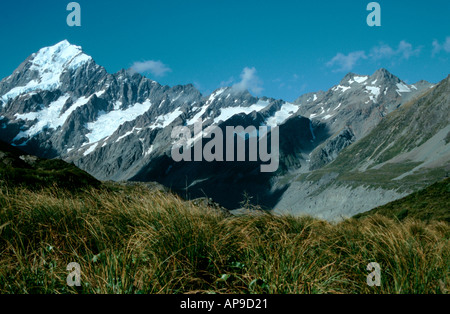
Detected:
[{"left": 0, "top": 186, "right": 450, "bottom": 294}]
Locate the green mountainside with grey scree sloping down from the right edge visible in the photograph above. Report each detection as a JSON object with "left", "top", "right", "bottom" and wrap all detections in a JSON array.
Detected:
[{"left": 276, "top": 76, "right": 450, "bottom": 219}]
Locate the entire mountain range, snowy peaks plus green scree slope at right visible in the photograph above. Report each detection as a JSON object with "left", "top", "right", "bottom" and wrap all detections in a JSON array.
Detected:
[{"left": 0, "top": 41, "right": 450, "bottom": 220}]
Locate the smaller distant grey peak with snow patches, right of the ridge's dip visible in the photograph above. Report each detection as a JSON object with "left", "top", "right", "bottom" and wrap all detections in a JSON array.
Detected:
[{"left": 295, "top": 69, "right": 431, "bottom": 139}]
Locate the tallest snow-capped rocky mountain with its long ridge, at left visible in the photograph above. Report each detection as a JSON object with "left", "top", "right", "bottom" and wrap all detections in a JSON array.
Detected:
[{"left": 0, "top": 41, "right": 314, "bottom": 207}]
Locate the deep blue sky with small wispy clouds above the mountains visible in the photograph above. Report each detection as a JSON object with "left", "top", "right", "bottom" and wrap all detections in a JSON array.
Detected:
[{"left": 0, "top": 0, "right": 450, "bottom": 101}]
